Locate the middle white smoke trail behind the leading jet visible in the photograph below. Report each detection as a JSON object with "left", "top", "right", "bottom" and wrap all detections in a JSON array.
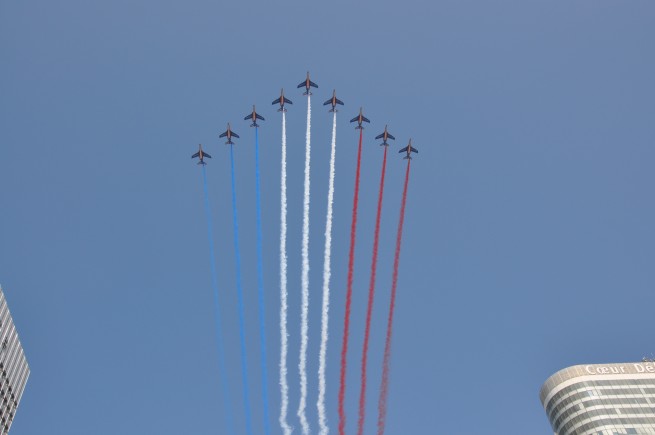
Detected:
[{"left": 298, "top": 93, "right": 312, "bottom": 435}]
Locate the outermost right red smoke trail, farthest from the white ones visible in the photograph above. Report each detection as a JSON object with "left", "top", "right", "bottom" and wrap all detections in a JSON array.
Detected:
[{"left": 378, "top": 160, "right": 411, "bottom": 435}]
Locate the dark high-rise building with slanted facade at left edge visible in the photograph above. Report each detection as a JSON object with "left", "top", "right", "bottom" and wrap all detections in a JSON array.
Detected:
[{"left": 0, "top": 288, "right": 30, "bottom": 435}]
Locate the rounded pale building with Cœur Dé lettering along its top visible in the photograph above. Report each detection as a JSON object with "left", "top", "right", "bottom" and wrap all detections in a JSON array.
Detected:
[{"left": 539, "top": 360, "right": 655, "bottom": 435}]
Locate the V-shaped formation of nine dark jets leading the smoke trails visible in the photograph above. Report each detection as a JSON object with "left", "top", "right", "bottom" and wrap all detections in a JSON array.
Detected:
[{"left": 191, "top": 71, "right": 418, "bottom": 165}]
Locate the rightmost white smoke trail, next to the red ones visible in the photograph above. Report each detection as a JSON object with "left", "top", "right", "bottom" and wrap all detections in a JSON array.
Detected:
[{"left": 316, "top": 110, "right": 337, "bottom": 435}]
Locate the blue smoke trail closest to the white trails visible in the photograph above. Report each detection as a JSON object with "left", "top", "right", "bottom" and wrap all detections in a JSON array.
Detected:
[{"left": 255, "top": 127, "right": 271, "bottom": 435}]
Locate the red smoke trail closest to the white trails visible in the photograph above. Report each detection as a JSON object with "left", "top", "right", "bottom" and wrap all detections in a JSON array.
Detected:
[{"left": 339, "top": 129, "right": 364, "bottom": 435}]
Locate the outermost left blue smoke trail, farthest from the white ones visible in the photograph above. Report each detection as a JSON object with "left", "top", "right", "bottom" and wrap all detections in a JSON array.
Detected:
[{"left": 201, "top": 165, "right": 240, "bottom": 434}]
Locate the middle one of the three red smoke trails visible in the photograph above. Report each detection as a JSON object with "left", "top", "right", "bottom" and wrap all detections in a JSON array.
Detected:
[{"left": 357, "top": 147, "right": 387, "bottom": 435}]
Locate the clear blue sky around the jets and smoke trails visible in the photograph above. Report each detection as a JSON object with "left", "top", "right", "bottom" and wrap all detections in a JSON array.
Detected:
[{"left": 0, "top": 0, "right": 655, "bottom": 435}]
